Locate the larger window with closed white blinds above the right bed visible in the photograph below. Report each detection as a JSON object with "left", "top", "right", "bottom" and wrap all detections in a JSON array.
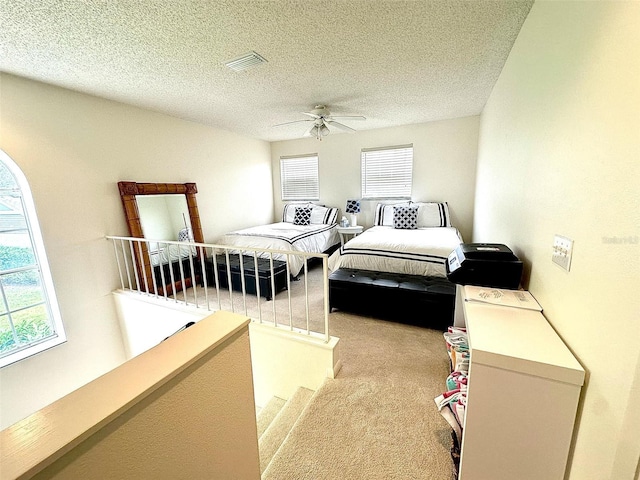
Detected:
[{"left": 362, "top": 145, "right": 413, "bottom": 198}]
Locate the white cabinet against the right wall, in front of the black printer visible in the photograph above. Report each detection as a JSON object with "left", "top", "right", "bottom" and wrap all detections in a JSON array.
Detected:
[{"left": 458, "top": 287, "right": 584, "bottom": 480}]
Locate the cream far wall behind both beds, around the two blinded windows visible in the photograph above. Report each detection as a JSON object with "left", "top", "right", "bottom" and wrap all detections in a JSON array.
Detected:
[{"left": 271, "top": 117, "right": 479, "bottom": 244}]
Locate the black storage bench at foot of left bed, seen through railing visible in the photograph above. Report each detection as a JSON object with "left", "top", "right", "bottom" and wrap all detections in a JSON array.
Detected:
[{"left": 206, "top": 255, "right": 287, "bottom": 300}]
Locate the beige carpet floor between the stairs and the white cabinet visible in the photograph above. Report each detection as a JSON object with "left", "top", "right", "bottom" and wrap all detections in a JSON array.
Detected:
[{"left": 263, "top": 313, "right": 453, "bottom": 480}]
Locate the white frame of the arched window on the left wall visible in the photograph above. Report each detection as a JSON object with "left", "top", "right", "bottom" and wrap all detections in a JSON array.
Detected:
[{"left": 0, "top": 150, "right": 67, "bottom": 368}]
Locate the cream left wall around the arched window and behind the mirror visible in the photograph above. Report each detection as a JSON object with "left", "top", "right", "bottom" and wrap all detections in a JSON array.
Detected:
[{"left": 0, "top": 74, "right": 273, "bottom": 428}]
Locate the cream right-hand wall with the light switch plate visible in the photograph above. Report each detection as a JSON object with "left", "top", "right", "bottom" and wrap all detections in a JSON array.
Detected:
[{"left": 474, "top": 1, "right": 640, "bottom": 480}]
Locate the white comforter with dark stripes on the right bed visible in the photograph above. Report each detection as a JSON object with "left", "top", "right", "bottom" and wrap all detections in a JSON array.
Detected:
[{"left": 329, "top": 227, "right": 462, "bottom": 277}]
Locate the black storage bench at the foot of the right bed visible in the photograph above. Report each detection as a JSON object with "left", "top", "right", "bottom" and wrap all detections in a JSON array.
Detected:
[{"left": 329, "top": 268, "right": 456, "bottom": 330}]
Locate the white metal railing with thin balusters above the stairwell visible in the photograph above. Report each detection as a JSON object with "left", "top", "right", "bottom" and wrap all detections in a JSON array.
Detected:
[{"left": 106, "top": 236, "right": 330, "bottom": 342}]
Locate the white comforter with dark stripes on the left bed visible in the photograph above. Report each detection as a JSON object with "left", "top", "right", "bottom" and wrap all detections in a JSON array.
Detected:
[{"left": 220, "top": 222, "right": 340, "bottom": 276}]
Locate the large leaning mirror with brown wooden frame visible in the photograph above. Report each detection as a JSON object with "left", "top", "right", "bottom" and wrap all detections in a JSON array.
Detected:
[{"left": 118, "top": 182, "right": 204, "bottom": 295}]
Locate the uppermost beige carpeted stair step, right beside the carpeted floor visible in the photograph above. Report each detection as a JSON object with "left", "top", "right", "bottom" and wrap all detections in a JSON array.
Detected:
[{"left": 258, "top": 387, "right": 314, "bottom": 472}]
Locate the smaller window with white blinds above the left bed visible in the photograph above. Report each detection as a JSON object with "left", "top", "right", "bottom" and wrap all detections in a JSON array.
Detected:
[{"left": 280, "top": 155, "right": 320, "bottom": 200}]
